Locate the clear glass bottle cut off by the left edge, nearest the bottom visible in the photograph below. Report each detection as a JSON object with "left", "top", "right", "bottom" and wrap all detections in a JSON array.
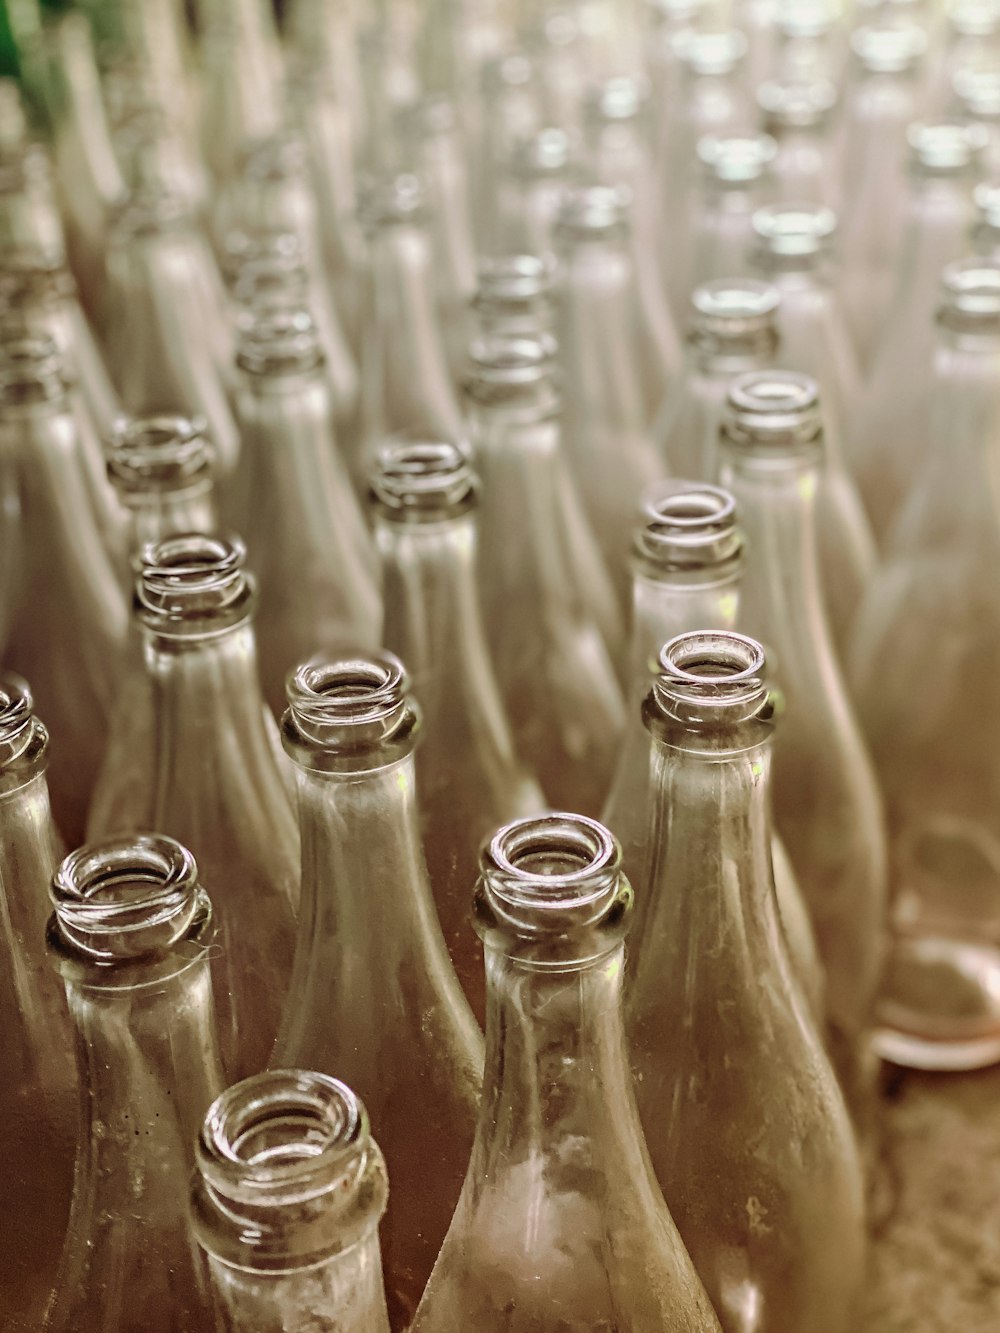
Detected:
[{"left": 0, "top": 673, "right": 79, "bottom": 1329}]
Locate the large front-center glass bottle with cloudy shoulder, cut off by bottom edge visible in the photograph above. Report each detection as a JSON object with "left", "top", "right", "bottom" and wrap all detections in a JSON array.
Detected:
[{"left": 413, "top": 814, "right": 719, "bottom": 1333}]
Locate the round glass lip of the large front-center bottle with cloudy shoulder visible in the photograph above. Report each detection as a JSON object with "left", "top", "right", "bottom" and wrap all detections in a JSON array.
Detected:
[{"left": 475, "top": 813, "right": 632, "bottom": 969}]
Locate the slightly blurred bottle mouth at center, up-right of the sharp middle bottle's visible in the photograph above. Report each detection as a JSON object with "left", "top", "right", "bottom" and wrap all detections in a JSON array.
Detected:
[{"left": 371, "top": 440, "right": 479, "bottom": 523}]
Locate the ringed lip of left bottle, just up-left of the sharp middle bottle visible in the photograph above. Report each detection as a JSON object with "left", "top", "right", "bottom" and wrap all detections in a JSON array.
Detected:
[{"left": 135, "top": 532, "right": 256, "bottom": 640}]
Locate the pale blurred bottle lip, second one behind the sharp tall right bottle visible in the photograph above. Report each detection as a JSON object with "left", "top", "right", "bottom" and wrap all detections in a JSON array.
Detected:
[{"left": 721, "top": 371, "right": 823, "bottom": 463}]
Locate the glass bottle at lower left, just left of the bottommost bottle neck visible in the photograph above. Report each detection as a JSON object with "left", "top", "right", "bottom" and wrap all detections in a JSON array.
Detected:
[{"left": 43, "top": 833, "right": 223, "bottom": 1333}]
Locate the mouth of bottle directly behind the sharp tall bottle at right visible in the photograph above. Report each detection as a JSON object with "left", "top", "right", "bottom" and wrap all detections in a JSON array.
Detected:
[{"left": 633, "top": 481, "right": 743, "bottom": 575}]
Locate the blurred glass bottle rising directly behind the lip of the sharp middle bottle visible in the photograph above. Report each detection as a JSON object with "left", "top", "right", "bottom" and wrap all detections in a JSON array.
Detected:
[{"left": 236, "top": 308, "right": 380, "bottom": 716}]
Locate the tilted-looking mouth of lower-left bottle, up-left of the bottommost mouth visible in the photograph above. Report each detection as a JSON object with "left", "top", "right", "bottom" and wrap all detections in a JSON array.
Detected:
[{"left": 52, "top": 833, "right": 211, "bottom": 964}]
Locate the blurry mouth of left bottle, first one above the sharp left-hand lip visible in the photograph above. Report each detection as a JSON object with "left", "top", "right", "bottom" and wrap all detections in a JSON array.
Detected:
[{"left": 107, "top": 416, "right": 215, "bottom": 497}]
